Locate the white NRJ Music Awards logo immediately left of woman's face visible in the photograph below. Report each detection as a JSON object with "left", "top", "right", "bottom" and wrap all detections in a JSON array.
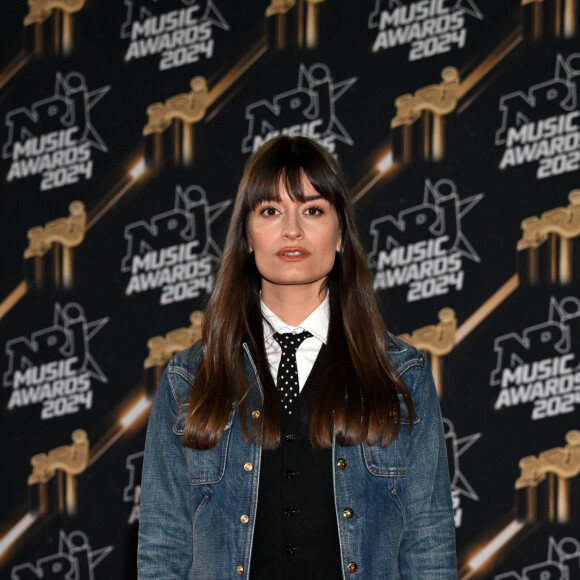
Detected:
[{"left": 121, "top": 185, "right": 230, "bottom": 305}]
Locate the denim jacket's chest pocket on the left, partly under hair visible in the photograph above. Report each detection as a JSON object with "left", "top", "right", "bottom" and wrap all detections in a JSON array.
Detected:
[{"left": 173, "top": 404, "right": 233, "bottom": 485}]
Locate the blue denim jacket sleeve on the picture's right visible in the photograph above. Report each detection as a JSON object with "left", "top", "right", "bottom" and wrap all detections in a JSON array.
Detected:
[{"left": 399, "top": 349, "right": 457, "bottom": 580}]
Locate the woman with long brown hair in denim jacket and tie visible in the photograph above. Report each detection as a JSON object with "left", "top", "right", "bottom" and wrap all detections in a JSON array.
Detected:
[{"left": 139, "top": 137, "right": 456, "bottom": 580}]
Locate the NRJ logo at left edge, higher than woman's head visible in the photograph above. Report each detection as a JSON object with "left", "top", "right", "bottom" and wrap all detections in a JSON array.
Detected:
[{"left": 2, "top": 72, "right": 110, "bottom": 191}]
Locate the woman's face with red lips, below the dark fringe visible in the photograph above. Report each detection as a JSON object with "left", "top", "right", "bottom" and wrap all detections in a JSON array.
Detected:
[{"left": 247, "top": 178, "right": 341, "bottom": 298}]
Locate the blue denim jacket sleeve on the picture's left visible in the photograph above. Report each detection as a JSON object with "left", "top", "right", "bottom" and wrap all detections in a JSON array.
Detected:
[{"left": 137, "top": 346, "right": 198, "bottom": 580}]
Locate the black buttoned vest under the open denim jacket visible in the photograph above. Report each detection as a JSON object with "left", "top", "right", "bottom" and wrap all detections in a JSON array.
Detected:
[{"left": 250, "top": 346, "right": 342, "bottom": 580}]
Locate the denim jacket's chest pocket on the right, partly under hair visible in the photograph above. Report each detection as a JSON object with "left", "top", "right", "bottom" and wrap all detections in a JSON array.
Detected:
[{"left": 362, "top": 404, "right": 419, "bottom": 477}]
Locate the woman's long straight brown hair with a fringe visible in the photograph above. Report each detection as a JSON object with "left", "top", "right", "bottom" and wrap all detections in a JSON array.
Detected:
[{"left": 183, "top": 137, "right": 414, "bottom": 449}]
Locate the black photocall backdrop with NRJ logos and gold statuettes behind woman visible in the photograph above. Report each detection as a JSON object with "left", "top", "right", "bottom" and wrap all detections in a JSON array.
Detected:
[{"left": 0, "top": 0, "right": 580, "bottom": 580}]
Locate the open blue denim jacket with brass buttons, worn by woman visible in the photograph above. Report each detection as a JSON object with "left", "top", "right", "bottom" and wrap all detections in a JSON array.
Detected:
[{"left": 138, "top": 337, "right": 457, "bottom": 580}]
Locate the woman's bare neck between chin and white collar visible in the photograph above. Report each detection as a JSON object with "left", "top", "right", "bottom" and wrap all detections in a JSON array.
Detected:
[{"left": 262, "top": 284, "right": 326, "bottom": 326}]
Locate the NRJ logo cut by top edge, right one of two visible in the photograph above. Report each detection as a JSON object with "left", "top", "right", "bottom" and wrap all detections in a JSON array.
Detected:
[{"left": 368, "top": 0, "right": 483, "bottom": 61}]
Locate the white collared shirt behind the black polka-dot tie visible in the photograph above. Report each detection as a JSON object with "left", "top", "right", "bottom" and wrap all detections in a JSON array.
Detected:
[{"left": 262, "top": 291, "right": 330, "bottom": 391}]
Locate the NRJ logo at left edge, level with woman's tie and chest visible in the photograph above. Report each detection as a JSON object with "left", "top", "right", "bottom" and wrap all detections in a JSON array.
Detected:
[{"left": 2, "top": 302, "right": 109, "bottom": 419}]
